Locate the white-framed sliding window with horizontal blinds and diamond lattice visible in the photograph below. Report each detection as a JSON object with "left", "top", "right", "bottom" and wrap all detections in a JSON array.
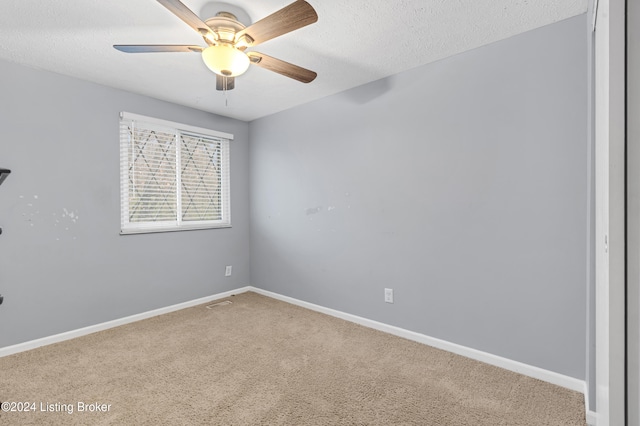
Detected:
[{"left": 120, "top": 112, "right": 233, "bottom": 234}]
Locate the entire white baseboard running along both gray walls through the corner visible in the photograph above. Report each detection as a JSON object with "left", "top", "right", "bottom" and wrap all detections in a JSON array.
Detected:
[{"left": 0, "top": 286, "right": 597, "bottom": 426}]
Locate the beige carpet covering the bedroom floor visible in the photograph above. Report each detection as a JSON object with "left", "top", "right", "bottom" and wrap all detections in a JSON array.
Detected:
[{"left": 0, "top": 293, "right": 585, "bottom": 426}]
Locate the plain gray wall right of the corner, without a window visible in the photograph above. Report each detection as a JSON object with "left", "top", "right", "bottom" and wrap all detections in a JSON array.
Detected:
[{"left": 250, "top": 15, "right": 588, "bottom": 379}]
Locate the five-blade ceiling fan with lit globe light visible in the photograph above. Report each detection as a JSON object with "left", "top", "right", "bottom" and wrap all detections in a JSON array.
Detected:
[{"left": 113, "top": 0, "right": 318, "bottom": 90}]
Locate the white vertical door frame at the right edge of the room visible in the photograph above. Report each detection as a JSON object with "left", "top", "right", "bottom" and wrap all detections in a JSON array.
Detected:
[{"left": 594, "top": 0, "right": 626, "bottom": 426}]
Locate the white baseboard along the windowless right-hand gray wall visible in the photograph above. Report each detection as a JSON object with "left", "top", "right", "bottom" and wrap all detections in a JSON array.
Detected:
[{"left": 250, "top": 287, "right": 585, "bottom": 393}]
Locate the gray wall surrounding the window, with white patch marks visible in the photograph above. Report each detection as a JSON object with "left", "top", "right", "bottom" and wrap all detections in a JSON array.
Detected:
[{"left": 0, "top": 61, "right": 250, "bottom": 347}]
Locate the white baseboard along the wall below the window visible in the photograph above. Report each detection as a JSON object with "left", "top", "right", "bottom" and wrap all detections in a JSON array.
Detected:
[{"left": 0, "top": 287, "right": 252, "bottom": 358}]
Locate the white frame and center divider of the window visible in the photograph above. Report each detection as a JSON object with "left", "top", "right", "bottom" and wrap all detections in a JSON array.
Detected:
[{"left": 118, "top": 111, "right": 233, "bottom": 235}]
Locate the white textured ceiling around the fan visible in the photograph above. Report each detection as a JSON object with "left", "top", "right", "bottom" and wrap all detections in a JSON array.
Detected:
[{"left": 0, "top": 0, "right": 588, "bottom": 121}]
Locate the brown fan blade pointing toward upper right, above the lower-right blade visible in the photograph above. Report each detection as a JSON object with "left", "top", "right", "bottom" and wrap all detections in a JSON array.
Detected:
[{"left": 235, "top": 0, "right": 318, "bottom": 46}]
